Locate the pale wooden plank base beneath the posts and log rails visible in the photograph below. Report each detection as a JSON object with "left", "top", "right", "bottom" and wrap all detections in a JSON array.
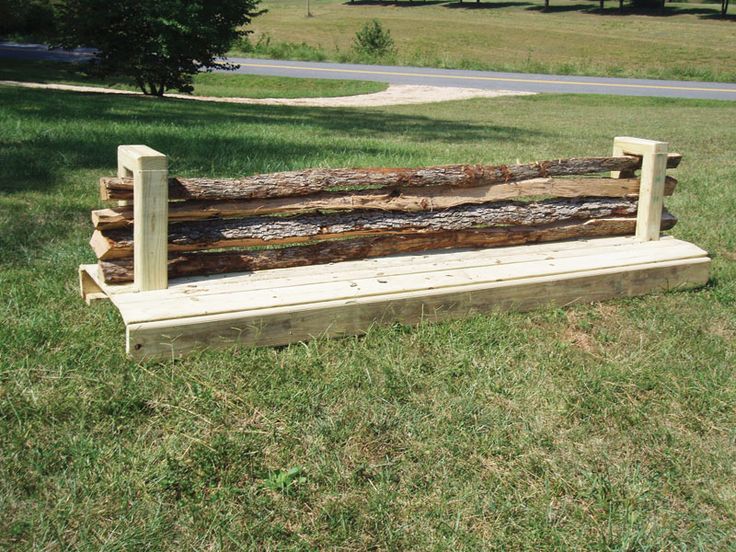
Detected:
[{"left": 80, "top": 237, "right": 710, "bottom": 359}]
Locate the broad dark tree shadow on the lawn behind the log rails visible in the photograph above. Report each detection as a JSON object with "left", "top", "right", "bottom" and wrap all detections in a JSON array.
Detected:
[{"left": 0, "top": 88, "right": 543, "bottom": 197}]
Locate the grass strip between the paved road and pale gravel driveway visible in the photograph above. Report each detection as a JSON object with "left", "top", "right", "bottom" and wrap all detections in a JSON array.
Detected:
[{"left": 0, "top": 58, "right": 387, "bottom": 98}]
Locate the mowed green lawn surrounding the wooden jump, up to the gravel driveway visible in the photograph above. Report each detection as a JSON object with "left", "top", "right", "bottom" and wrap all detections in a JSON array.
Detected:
[{"left": 0, "top": 87, "right": 736, "bottom": 550}]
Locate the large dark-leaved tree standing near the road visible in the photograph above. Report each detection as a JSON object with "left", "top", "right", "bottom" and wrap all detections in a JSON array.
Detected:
[{"left": 54, "top": 0, "right": 263, "bottom": 96}]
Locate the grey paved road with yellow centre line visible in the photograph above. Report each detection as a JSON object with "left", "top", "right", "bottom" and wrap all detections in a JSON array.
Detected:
[{"left": 5, "top": 42, "right": 736, "bottom": 101}]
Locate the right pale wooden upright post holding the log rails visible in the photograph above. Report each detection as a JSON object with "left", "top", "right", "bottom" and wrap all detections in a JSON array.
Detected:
[{"left": 611, "top": 136, "right": 667, "bottom": 241}]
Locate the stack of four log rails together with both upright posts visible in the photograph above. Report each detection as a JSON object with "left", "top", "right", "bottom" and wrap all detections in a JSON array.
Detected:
[{"left": 90, "top": 138, "right": 681, "bottom": 290}]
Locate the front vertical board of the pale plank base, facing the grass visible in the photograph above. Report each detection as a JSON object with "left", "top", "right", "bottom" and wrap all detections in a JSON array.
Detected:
[{"left": 126, "top": 257, "right": 710, "bottom": 359}]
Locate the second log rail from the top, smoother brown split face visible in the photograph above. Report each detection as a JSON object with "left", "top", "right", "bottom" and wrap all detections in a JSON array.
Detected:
[{"left": 92, "top": 176, "right": 677, "bottom": 230}]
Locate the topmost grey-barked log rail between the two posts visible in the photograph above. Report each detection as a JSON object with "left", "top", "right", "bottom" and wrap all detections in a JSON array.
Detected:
[{"left": 100, "top": 154, "right": 681, "bottom": 201}]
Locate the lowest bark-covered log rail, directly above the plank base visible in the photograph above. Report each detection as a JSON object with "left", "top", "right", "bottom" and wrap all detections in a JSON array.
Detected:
[{"left": 99, "top": 212, "right": 677, "bottom": 284}]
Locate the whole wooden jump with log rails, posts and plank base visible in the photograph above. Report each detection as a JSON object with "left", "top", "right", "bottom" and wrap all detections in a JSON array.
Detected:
[{"left": 79, "top": 138, "right": 710, "bottom": 358}]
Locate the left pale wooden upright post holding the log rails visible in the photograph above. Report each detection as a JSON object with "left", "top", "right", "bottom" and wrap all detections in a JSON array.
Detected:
[{"left": 118, "top": 146, "right": 169, "bottom": 291}]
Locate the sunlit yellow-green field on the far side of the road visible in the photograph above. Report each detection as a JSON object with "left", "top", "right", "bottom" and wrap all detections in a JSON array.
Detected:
[{"left": 240, "top": 0, "right": 736, "bottom": 82}]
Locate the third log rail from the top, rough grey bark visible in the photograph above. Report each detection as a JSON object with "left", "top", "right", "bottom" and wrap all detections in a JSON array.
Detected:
[{"left": 90, "top": 198, "right": 637, "bottom": 260}]
